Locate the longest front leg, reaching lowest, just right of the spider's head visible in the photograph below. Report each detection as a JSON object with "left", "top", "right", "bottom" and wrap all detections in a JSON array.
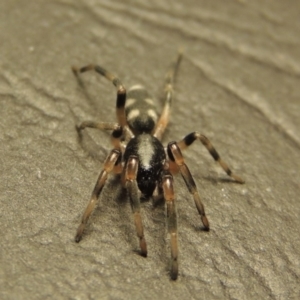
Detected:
[{"left": 162, "top": 174, "right": 178, "bottom": 280}]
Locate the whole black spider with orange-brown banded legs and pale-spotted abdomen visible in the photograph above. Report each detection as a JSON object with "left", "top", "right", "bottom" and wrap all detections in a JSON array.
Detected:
[{"left": 72, "top": 51, "right": 244, "bottom": 280}]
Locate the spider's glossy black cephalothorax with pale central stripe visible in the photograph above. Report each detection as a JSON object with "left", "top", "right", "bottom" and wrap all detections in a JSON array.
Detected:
[{"left": 124, "top": 133, "right": 166, "bottom": 197}]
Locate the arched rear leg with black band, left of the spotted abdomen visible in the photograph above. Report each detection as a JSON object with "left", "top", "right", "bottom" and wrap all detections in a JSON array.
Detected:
[{"left": 72, "top": 65, "right": 127, "bottom": 128}]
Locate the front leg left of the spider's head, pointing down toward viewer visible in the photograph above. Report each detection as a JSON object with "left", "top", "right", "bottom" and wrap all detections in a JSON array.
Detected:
[{"left": 125, "top": 155, "right": 147, "bottom": 257}]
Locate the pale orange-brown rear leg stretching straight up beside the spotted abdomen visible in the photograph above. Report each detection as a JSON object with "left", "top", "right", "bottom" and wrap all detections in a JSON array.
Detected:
[{"left": 153, "top": 51, "right": 182, "bottom": 140}]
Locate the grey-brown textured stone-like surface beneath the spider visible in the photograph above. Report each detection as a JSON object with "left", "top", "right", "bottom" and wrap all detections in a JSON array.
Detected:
[{"left": 0, "top": 0, "right": 300, "bottom": 299}]
